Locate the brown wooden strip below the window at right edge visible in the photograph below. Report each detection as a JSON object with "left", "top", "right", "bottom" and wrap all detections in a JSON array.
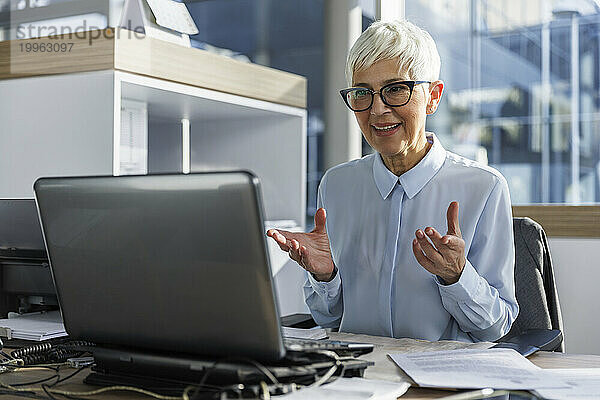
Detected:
[{"left": 512, "top": 205, "right": 600, "bottom": 238}]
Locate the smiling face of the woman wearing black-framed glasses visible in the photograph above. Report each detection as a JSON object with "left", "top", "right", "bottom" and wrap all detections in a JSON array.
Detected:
[{"left": 352, "top": 59, "right": 443, "bottom": 172}]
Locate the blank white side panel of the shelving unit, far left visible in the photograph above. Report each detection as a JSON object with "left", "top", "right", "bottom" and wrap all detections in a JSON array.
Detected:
[{"left": 0, "top": 71, "right": 114, "bottom": 197}]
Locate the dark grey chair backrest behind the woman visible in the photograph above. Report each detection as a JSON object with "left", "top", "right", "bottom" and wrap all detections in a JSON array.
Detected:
[{"left": 505, "top": 218, "right": 564, "bottom": 351}]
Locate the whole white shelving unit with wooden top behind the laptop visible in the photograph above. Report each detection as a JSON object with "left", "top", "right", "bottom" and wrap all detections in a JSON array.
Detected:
[{"left": 0, "top": 28, "right": 307, "bottom": 314}]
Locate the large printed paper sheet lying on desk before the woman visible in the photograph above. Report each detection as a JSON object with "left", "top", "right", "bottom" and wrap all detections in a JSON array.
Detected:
[{"left": 390, "top": 349, "right": 568, "bottom": 390}]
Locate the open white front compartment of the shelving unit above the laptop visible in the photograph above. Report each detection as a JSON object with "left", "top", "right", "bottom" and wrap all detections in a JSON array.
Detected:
[{"left": 113, "top": 71, "right": 306, "bottom": 226}]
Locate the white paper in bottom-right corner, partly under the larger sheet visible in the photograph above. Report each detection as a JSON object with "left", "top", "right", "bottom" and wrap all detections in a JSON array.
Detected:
[{"left": 536, "top": 368, "right": 600, "bottom": 400}]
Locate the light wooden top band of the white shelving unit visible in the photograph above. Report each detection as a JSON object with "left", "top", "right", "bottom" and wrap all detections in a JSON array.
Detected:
[{"left": 0, "top": 28, "right": 307, "bottom": 108}]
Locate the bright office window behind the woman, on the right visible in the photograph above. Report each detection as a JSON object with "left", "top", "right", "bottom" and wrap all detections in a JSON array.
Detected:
[{"left": 405, "top": 0, "right": 600, "bottom": 204}]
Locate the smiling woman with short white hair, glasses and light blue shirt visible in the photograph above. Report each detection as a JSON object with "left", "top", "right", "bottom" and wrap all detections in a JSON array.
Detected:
[{"left": 267, "top": 21, "right": 519, "bottom": 341}]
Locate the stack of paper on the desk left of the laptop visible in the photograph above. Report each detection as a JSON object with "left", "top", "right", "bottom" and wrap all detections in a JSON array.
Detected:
[{"left": 0, "top": 311, "right": 67, "bottom": 342}]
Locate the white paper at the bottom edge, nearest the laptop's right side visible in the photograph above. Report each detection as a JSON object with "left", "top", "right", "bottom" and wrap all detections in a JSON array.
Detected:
[{"left": 277, "top": 378, "right": 410, "bottom": 400}]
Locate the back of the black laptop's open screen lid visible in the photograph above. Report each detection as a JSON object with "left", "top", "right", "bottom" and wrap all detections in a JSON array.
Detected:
[{"left": 34, "top": 172, "right": 284, "bottom": 360}]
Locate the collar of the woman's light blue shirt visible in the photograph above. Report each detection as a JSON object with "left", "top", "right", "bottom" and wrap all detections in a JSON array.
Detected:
[{"left": 373, "top": 133, "right": 446, "bottom": 200}]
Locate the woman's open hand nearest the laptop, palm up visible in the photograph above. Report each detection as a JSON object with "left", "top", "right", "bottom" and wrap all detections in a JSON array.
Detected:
[{"left": 267, "top": 208, "right": 334, "bottom": 282}]
